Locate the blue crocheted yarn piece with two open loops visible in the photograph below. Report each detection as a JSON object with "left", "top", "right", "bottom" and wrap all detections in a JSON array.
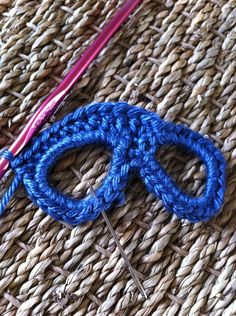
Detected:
[{"left": 0, "top": 102, "right": 226, "bottom": 225}]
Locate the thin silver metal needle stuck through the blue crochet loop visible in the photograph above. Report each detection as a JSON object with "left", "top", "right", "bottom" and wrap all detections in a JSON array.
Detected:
[{"left": 89, "top": 182, "right": 148, "bottom": 299}]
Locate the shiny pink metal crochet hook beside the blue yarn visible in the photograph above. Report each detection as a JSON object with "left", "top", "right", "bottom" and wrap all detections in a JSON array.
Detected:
[{"left": 0, "top": 0, "right": 143, "bottom": 180}]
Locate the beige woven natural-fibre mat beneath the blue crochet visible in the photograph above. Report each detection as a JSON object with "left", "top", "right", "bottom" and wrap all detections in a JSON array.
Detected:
[{"left": 0, "top": 0, "right": 236, "bottom": 316}]
